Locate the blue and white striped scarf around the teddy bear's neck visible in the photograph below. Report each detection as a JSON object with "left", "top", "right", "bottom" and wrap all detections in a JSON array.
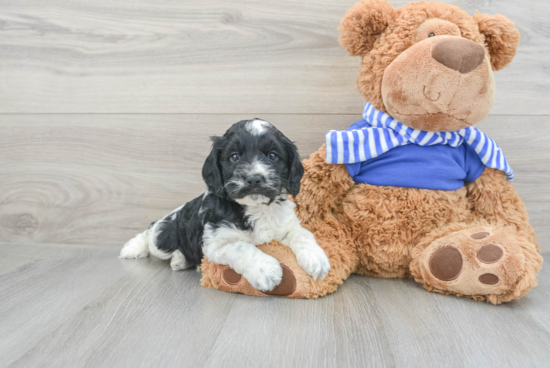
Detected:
[{"left": 325, "top": 102, "right": 514, "bottom": 181}]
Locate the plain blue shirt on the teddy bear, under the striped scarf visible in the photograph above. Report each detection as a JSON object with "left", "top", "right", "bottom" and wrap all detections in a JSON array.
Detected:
[{"left": 346, "top": 119, "right": 485, "bottom": 190}]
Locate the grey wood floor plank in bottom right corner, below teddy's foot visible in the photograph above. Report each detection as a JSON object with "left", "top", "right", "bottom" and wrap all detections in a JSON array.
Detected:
[{"left": 366, "top": 276, "right": 550, "bottom": 367}]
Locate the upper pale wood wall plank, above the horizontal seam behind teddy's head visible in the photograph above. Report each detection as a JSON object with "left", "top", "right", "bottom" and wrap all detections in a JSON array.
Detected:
[{"left": 0, "top": 0, "right": 550, "bottom": 114}]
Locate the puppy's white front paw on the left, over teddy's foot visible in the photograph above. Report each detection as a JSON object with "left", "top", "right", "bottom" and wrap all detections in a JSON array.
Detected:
[{"left": 243, "top": 254, "right": 283, "bottom": 291}]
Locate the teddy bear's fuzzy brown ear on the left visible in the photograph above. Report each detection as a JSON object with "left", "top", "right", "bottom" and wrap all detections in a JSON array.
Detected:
[{"left": 338, "top": 0, "right": 393, "bottom": 56}]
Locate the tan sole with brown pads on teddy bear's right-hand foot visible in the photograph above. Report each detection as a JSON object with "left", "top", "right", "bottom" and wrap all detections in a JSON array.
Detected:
[{"left": 420, "top": 229, "right": 525, "bottom": 295}]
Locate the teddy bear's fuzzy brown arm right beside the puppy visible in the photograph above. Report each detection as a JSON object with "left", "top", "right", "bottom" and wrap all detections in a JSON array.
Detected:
[{"left": 296, "top": 145, "right": 354, "bottom": 224}]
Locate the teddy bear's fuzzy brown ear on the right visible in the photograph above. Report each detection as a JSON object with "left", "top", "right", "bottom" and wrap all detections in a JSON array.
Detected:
[{"left": 474, "top": 13, "right": 520, "bottom": 71}]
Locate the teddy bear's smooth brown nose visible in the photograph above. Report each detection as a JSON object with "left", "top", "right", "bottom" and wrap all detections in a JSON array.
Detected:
[{"left": 432, "top": 37, "right": 485, "bottom": 74}]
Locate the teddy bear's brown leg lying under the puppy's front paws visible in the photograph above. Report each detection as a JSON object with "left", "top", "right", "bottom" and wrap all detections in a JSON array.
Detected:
[{"left": 201, "top": 219, "right": 358, "bottom": 299}]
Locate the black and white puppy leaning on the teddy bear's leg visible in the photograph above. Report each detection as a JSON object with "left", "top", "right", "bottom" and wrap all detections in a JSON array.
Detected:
[{"left": 120, "top": 119, "right": 330, "bottom": 291}]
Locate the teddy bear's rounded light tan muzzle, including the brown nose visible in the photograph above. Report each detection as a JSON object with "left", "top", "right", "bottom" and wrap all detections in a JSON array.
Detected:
[{"left": 382, "top": 35, "right": 495, "bottom": 131}]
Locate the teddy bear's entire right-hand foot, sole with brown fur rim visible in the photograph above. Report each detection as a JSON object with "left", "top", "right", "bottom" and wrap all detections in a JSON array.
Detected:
[{"left": 411, "top": 226, "right": 542, "bottom": 304}]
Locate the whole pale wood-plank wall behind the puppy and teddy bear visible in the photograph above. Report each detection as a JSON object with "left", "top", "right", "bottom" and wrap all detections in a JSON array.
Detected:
[{"left": 0, "top": 0, "right": 550, "bottom": 251}]
